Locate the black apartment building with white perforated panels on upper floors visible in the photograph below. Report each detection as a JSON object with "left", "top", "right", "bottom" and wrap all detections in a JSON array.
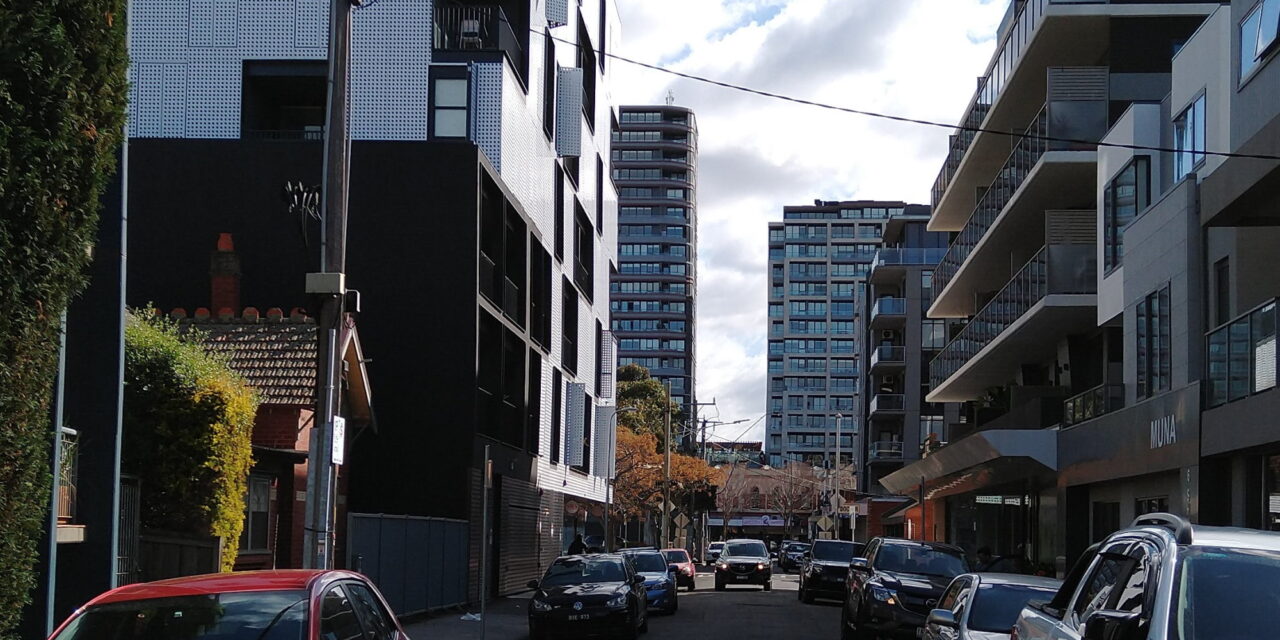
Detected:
[{"left": 52, "top": 0, "right": 618, "bottom": 603}]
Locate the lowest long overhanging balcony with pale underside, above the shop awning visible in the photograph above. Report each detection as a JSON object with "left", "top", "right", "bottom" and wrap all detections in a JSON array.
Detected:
[{"left": 925, "top": 244, "right": 1097, "bottom": 402}]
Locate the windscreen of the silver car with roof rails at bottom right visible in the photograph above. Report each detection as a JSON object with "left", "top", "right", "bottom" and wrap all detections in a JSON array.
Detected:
[{"left": 1170, "top": 547, "right": 1280, "bottom": 640}]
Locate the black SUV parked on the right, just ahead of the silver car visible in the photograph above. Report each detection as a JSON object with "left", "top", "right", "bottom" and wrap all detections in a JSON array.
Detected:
[{"left": 840, "top": 538, "right": 969, "bottom": 640}]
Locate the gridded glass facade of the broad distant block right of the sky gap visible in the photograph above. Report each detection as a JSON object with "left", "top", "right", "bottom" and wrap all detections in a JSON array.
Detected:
[{"left": 764, "top": 201, "right": 928, "bottom": 476}]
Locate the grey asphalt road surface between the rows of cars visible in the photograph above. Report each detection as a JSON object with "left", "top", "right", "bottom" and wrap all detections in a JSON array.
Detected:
[{"left": 406, "top": 571, "right": 840, "bottom": 640}]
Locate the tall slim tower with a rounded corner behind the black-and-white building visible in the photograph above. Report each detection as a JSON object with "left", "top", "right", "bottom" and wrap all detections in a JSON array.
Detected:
[{"left": 609, "top": 105, "right": 698, "bottom": 432}]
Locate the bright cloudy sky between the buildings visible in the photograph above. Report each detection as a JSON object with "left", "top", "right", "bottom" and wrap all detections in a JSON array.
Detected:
[{"left": 609, "top": 0, "right": 1009, "bottom": 440}]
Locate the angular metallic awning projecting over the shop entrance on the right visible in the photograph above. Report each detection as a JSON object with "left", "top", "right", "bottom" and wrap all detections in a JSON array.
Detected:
[{"left": 881, "top": 429, "right": 1057, "bottom": 498}]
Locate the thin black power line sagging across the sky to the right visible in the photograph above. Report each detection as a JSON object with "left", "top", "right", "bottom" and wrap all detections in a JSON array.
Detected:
[{"left": 529, "top": 28, "right": 1280, "bottom": 160}]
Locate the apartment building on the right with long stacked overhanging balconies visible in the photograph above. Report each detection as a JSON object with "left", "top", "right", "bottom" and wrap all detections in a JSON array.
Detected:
[{"left": 881, "top": 0, "right": 1220, "bottom": 570}]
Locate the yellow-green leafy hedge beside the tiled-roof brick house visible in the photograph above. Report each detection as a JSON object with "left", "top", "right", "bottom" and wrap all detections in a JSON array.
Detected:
[{"left": 122, "top": 311, "right": 259, "bottom": 571}]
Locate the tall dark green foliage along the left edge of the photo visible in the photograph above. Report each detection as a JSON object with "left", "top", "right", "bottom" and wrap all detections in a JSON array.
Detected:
[{"left": 0, "top": 0, "right": 128, "bottom": 629}]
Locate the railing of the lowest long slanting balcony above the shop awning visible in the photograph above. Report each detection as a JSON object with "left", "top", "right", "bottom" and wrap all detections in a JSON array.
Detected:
[{"left": 929, "top": 244, "right": 1097, "bottom": 388}]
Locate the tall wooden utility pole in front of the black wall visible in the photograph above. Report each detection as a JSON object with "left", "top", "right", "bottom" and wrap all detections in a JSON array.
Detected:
[{"left": 302, "top": 0, "right": 352, "bottom": 568}]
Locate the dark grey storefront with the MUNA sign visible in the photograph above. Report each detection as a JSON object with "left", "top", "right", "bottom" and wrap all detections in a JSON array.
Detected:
[{"left": 1059, "top": 384, "right": 1201, "bottom": 564}]
